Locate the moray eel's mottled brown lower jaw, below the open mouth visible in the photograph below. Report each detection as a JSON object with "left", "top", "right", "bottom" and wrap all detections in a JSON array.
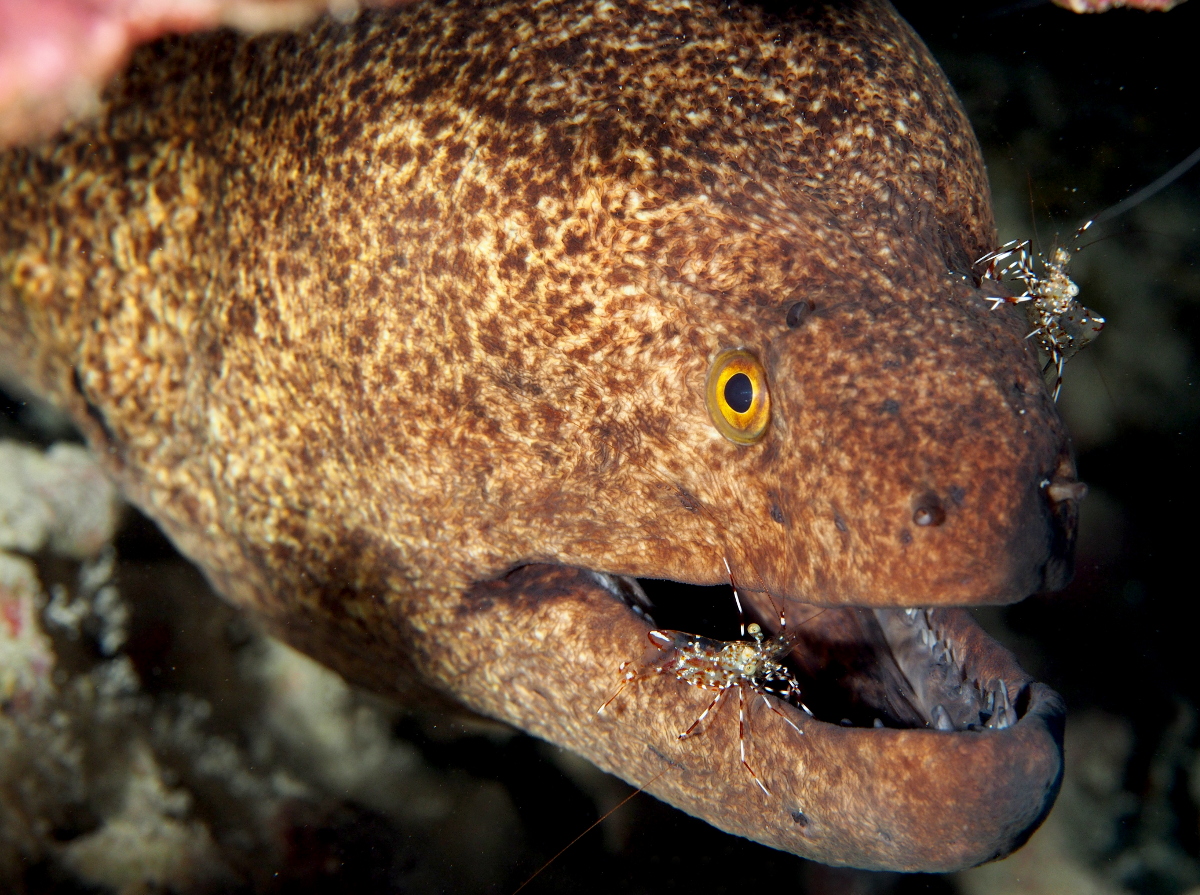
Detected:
[{"left": 456, "top": 566, "right": 1064, "bottom": 871}]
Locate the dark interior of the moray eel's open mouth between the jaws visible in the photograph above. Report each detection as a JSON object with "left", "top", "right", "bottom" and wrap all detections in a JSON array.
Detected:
[{"left": 638, "top": 578, "right": 1028, "bottom": 731}]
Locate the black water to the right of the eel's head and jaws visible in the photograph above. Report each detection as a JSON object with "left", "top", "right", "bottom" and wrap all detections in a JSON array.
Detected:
[{"left": 905, "top": 4, "right": 1200, "bottom": 893}]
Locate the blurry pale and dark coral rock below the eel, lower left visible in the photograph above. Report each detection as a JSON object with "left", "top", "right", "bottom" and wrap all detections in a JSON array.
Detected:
[{"left": 0, "top": 442, "right": 515, "bottom": 895}]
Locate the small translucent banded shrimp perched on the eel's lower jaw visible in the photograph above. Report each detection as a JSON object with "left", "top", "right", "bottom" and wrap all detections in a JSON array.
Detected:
[{"left": 596, "top": 559, "right": 812, "bottom": 795}]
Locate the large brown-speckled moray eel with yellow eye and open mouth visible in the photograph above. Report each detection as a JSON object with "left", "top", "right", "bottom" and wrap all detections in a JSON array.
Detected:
[{"left": 0, "top": 0, "right": 1080, "bottom": 870}]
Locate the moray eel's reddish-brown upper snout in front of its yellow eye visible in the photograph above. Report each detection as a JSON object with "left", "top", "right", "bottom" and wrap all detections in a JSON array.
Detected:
[{"left": 758, "top": 275, "right": 1086, "bottom": 606}]
